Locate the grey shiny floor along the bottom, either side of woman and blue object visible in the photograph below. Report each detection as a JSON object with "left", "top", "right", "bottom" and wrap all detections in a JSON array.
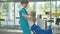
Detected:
[{"left": 0, "top": 25, "right": 60, "bottom": 34}]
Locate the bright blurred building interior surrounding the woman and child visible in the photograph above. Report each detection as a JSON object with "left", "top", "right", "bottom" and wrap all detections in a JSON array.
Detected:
[{"left": 0, "top": 0, "right": 60, "bottom": 34}]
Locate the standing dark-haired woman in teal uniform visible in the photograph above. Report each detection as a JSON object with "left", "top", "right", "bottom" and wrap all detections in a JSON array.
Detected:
[{"left": 19, "top": 0, "right": 31, "bottom": 34}]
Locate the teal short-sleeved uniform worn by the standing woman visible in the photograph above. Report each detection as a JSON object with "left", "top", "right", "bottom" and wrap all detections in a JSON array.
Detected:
[{"left": 19, "top": 8, "right": 31, "bottom": 34}]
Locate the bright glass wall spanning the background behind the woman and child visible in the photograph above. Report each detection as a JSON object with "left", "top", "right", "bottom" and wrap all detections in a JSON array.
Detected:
[{"left": 0, "top": 1, "right": 60, "bottom": 27}]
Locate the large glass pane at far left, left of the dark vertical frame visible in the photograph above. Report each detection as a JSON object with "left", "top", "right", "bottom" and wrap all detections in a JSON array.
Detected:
[{"left": 0, "top": 2, "right": 14, "bottom": 27}]
